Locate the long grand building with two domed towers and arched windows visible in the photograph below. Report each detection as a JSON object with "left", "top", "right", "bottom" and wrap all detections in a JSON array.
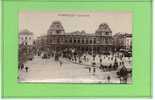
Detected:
[{"left": 47, "top": 21, "right": 112, "bottom": 53}]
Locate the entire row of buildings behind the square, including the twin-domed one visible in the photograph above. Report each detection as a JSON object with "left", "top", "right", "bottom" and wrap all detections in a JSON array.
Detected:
[{"left": 19, "top": 21, "right": 132, "bottom": 53}]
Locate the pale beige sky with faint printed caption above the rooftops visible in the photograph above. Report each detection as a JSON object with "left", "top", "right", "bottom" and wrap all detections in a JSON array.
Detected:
[{"left": 19, "top": 11, "right": 132, "bottom": 36}]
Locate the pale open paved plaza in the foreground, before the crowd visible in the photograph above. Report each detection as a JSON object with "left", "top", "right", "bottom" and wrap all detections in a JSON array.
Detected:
[{"left": 18, "top": 56, "right": 131, "bottom": 83}]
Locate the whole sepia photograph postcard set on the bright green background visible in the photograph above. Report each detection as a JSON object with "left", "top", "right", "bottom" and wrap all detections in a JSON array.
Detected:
[{"left": 17, "top": 11, "right": 133, "bottom": 84}]
